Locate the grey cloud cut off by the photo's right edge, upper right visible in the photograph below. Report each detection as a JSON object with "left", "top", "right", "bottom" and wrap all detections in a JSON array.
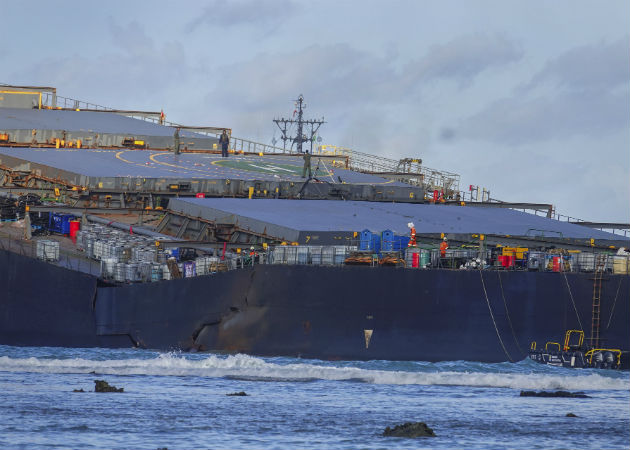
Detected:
[{"left": 525, "top": 36, "right": 630, "bottom": 90}]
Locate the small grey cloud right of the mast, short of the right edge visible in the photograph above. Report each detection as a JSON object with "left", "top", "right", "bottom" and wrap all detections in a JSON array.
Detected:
[{"left": 405, "top": 33, "right": 523, "bottom": 86}]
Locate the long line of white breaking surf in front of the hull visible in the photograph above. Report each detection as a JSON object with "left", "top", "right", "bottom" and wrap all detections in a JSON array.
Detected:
[{"left": 0, "top": 354, "right": 630, "bottom": 391}]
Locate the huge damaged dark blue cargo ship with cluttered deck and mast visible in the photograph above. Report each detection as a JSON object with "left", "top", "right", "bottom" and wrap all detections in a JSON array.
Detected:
[{"left": 0, "top": 86, "right": 630, "bottom": 368}]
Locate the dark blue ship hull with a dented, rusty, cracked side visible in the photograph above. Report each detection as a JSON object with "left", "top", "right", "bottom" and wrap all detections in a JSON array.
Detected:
[{"left": 0, "top": 250, "right": 630, "bottom": 362}]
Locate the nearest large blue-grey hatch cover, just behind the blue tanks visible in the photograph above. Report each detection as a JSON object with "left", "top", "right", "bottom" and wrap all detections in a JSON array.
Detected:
[{"left": 169, "top": 198, "right": 630, "bottom": 246}]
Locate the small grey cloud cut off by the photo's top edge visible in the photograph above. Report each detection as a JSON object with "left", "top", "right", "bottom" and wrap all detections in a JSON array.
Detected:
[{"left": 188, "top": 0, "right": 300, "bottom": 31}]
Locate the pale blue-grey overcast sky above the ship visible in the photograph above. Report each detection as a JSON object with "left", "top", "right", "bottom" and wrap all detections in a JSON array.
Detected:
[{"left": 0, "top": 0, "right": 630, "bottom": 222}]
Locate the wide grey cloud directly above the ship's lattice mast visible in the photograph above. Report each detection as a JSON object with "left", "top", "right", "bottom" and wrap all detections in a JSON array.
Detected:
[{"left": 208, "top": 44, "right": 396, "bottom": 109}]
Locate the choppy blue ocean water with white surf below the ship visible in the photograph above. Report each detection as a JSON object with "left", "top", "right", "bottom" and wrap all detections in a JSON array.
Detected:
[{"left": 0, "top": 346, "right": 630, "bottom": 450}]
